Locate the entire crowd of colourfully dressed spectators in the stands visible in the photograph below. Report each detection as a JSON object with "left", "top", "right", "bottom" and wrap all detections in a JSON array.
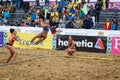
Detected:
[{"left": 0, "top": 0, "right": 118, "bottom": 30}]
